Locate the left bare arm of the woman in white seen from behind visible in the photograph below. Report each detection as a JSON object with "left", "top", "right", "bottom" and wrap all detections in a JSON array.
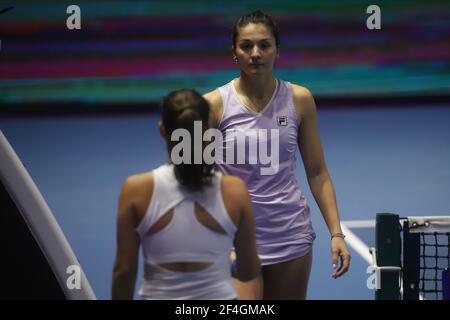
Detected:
[{"left": 112, "top": 178, "right": 140, "bottom": 300}]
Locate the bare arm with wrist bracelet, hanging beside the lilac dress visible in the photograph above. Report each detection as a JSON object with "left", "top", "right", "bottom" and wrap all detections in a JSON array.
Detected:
[{"left": 293, "top": 85, "right": 350, "bottom": 278}]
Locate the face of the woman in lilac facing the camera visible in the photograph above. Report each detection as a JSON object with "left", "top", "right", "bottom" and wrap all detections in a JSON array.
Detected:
[{"left": 233, "top": 23, "right": 278, "bottom": 75}]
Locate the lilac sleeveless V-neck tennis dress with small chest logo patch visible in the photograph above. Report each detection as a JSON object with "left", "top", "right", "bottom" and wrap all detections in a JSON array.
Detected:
[{"left": 217, "top": 80, "right": 316, "bottom": 265}]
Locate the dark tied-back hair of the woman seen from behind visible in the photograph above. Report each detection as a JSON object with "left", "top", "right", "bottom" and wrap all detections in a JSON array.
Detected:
[{"left": 161, "top": 89, "right": 213, "bottom": 191}]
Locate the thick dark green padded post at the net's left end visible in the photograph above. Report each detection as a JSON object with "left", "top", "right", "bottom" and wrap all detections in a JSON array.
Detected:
[{"left": 375, "top": 213, "right": 401, "bottom": 300}]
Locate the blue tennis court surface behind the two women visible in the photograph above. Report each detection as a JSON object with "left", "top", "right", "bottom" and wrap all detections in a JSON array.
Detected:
[{"left": 0, "top": 105, "right": 450, "bottom": 300}]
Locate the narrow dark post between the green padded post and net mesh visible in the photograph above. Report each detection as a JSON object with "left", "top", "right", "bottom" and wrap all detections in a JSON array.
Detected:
[{"left": 403, "top": 220, "right": 420, "bottom": 300}]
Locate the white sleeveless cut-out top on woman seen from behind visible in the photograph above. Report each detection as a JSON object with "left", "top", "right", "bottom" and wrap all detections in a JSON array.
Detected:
[{"left": 136, "top": 164, "right": 237, "bottom": 299}]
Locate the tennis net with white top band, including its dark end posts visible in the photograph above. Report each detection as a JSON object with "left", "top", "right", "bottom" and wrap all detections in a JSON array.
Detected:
[{"left": 372, "top": 213, "right": 450, "bottom": 300}]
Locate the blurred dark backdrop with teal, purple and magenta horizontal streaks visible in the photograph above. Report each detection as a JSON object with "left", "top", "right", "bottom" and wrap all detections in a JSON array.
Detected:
[{"left": 0, "top": 0, "right": 450, "bottom": 108}]
